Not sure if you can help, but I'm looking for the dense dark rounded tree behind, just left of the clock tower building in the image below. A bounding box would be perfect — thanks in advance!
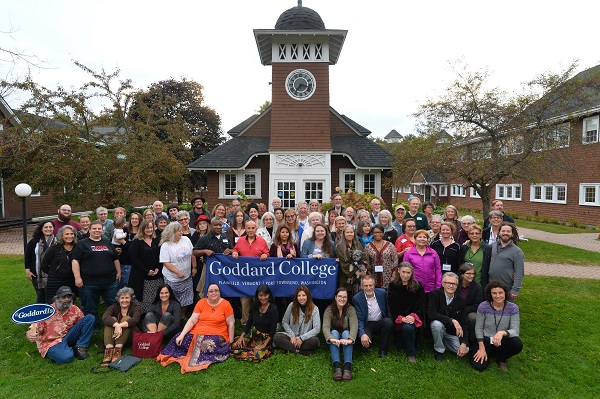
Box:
[131,78,224,202]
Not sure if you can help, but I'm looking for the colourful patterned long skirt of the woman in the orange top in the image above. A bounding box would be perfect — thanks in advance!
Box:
[156,333,230,374]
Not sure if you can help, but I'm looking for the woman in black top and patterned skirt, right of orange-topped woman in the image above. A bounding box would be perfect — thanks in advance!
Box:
[231,284,279,362]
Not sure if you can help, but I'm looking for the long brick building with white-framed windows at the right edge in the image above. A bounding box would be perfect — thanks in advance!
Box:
[403,65,600,225]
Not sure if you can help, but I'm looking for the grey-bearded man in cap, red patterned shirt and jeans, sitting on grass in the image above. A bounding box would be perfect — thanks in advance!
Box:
[26,286,95,364]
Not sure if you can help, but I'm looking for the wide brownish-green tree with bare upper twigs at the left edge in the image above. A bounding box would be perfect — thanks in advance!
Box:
[0,62,219,205]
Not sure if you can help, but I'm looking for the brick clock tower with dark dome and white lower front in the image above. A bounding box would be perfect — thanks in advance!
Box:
[254,6,347,205]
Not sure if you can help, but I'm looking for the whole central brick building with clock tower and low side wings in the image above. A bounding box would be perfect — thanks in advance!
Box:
[188,6,392,208]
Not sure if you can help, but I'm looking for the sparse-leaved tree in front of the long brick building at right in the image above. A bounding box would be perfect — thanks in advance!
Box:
[408,63,597,211]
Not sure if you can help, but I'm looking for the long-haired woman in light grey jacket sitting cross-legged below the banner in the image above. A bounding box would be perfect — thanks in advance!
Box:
[273,285,321,356]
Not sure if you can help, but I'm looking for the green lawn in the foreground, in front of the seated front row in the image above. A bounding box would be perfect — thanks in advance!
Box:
[0,256,600,399]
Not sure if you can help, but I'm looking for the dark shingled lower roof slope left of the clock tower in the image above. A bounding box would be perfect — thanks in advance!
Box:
[187,136,270,170]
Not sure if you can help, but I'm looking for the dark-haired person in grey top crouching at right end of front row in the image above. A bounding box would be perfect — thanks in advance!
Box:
[471,280,523,371]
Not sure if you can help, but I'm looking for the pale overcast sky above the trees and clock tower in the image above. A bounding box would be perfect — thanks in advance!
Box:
[0,0,600,138]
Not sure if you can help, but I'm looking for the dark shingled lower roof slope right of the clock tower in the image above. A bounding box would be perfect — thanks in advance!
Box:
[331,136,392,169]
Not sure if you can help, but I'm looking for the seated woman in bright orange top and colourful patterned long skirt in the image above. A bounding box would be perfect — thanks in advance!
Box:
[156,284,235,374]
